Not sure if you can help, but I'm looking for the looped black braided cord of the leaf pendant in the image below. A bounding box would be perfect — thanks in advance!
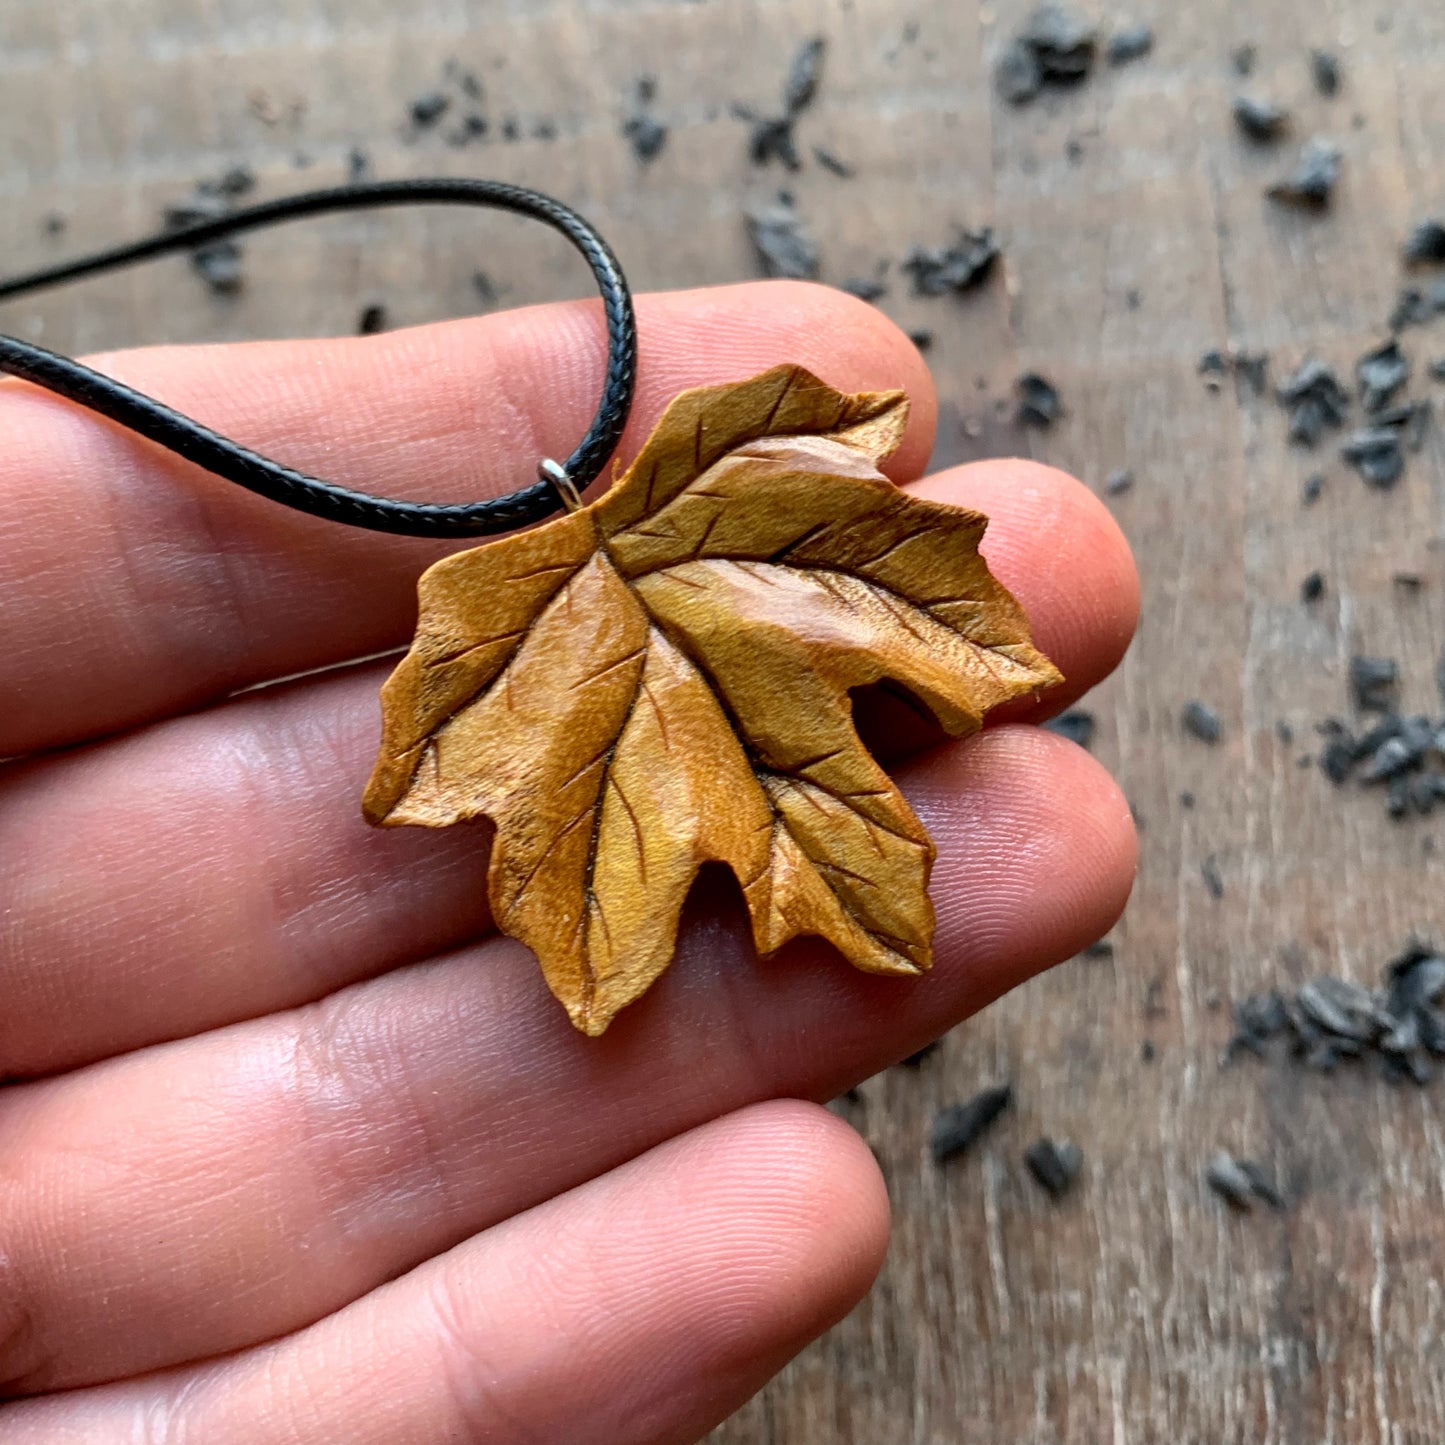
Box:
[0,181,637,538]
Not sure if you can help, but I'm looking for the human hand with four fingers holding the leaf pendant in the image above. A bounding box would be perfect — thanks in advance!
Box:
[0,283,1137,1445]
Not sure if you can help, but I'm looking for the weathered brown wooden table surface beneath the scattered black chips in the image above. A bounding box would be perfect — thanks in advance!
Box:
[0,0,1445,1445]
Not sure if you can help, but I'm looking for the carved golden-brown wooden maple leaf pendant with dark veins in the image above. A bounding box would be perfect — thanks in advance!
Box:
[364,367,1059,1035]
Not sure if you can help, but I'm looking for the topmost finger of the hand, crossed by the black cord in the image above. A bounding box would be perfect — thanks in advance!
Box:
[0,282,933,757]
